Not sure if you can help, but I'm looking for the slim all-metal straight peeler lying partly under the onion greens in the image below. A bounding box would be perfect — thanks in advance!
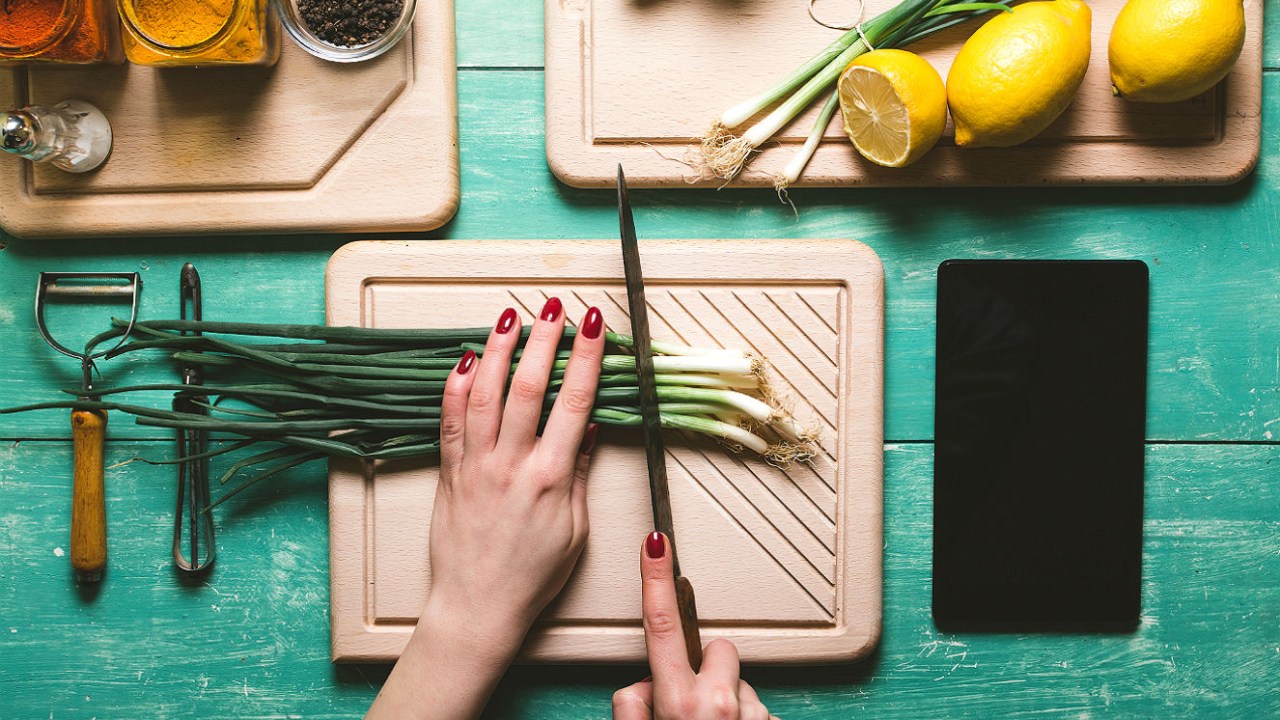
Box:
[173,263,218,574]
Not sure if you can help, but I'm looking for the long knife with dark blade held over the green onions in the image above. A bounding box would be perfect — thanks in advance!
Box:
[618,165,703,671]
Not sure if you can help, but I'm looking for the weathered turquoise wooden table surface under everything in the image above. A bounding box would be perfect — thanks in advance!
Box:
[0,0,1280,720]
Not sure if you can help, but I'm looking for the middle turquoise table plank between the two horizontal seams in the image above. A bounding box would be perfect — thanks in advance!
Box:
[0,72,1280,442]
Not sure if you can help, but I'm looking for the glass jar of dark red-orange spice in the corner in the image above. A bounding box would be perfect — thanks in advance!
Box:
[0,0,123,64]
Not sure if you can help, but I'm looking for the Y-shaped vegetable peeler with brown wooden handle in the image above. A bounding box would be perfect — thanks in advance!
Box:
[36,273,142,583]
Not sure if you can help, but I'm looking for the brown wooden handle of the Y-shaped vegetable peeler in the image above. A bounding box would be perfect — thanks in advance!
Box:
[72,410,106,582]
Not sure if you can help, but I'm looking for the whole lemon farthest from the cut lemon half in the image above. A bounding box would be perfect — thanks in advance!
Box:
[1107,0,1244,102]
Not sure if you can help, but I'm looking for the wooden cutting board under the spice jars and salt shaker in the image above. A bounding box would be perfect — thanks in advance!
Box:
[0,0,458,237]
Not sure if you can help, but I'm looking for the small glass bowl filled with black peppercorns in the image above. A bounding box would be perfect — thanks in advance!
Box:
[271,0,416,63]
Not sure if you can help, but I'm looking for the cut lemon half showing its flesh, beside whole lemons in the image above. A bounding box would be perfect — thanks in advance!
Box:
[837,50,947,168]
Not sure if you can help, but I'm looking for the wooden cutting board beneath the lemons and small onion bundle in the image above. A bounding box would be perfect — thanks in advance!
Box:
[545,0,1263,187]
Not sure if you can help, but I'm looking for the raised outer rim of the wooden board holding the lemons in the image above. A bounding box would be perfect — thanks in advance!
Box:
[544,0,1265,190]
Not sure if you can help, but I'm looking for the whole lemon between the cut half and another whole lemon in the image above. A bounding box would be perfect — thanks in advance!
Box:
[947,0,1092,147]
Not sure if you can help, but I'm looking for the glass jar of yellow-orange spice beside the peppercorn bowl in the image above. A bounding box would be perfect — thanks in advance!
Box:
[117,0,280,65]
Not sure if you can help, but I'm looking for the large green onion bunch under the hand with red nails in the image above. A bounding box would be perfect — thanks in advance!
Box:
[0,320,815,505]
